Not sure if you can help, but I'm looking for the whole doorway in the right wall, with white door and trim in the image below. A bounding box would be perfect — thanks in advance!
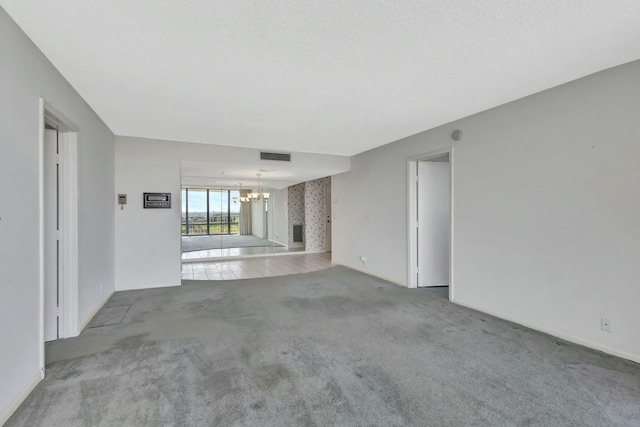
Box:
[408,148,453,299]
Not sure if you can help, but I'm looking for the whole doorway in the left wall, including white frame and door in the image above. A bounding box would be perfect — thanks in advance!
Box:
[39,99,79,369]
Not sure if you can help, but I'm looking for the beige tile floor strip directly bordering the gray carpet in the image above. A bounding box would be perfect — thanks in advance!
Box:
[182,253,331,280]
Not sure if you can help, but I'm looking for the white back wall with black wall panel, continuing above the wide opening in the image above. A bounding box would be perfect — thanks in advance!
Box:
[111,136,350,290]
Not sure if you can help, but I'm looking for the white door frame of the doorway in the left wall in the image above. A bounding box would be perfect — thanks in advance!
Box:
[38,98,80,375]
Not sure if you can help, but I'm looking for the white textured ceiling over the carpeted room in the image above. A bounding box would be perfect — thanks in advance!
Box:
[0,0,640,155]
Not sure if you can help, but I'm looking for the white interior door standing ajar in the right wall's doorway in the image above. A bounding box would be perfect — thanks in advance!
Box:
[418,161,450,287]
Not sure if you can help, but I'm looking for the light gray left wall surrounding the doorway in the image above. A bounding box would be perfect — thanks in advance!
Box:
[0,8,114,424]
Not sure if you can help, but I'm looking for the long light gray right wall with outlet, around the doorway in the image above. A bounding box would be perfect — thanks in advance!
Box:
[332,62,640,361]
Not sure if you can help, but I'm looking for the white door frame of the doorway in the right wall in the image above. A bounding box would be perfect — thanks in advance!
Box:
[407,147,455,301]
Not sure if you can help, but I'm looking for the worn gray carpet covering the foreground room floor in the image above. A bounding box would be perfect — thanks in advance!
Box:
[7,267,640,426]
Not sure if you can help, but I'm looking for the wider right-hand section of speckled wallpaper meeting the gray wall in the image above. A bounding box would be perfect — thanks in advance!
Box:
[304,176,331,251]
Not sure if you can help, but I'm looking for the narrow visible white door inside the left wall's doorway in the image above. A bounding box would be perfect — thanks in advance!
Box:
[43,129,59,341]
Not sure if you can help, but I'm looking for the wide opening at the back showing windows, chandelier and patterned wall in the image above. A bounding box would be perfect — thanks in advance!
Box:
[181,172,332,272]
